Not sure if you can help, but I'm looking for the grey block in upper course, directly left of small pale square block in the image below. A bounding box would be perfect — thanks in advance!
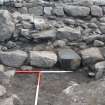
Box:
[29,6,43,16]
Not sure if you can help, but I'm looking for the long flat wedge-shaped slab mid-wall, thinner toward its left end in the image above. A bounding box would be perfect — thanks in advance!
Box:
[32,30,56,40]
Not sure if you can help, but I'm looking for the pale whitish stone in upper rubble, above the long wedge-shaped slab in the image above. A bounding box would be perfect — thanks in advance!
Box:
[34,17,49,30]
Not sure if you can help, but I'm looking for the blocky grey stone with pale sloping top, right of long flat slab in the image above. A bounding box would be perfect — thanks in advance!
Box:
[57,26,81,40]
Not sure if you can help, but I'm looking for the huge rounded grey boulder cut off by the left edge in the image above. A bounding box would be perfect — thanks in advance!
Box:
[0,10,15,41]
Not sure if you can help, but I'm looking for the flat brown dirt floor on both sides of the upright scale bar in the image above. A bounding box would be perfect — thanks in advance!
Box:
[11,69,92,105]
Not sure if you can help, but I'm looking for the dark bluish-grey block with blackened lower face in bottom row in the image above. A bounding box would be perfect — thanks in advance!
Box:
[58,49,81,70]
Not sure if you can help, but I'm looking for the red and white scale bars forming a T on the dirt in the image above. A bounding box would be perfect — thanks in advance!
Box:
[16,69,73,105]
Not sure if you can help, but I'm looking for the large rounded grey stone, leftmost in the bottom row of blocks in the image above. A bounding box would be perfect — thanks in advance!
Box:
[0,50,27,67]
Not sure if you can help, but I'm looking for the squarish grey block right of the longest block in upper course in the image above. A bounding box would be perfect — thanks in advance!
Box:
[91,6,103,17]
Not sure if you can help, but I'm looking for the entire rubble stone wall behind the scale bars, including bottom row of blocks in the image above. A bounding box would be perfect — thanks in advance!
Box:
[0,0,105,78]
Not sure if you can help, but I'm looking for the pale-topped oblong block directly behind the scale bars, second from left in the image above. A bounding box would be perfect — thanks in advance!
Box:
[30,51,57,68]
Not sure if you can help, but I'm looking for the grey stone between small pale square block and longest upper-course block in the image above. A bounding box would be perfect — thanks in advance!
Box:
[52,6,64,17]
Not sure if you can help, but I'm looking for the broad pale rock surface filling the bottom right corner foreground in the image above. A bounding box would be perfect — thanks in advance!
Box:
[53,80,105,105]
